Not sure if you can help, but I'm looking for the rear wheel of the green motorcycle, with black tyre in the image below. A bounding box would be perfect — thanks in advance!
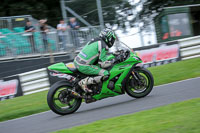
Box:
[47,83,82,115]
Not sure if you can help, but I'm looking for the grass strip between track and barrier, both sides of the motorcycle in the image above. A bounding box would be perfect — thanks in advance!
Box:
[0,58,200,121]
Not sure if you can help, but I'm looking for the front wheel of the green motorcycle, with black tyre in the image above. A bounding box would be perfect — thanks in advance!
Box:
[125,67,154,98]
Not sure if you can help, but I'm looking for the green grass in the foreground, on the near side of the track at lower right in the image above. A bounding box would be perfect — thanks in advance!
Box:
[55,98,200,133]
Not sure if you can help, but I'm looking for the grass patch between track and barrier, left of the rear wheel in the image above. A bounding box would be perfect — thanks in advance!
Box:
[0,91,49,121]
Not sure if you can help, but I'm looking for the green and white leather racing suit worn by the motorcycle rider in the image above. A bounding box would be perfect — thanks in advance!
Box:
[74,38,112,76]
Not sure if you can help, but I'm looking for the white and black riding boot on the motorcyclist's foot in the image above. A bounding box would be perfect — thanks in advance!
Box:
[78,76,102,93]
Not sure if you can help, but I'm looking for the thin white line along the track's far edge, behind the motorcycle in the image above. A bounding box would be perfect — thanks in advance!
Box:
[0,77,200,124]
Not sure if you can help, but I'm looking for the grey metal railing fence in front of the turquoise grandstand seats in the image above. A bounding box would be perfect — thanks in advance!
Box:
[0,26,100,57]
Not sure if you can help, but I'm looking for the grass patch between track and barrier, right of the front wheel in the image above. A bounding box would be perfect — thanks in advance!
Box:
[149,58,200,85]
